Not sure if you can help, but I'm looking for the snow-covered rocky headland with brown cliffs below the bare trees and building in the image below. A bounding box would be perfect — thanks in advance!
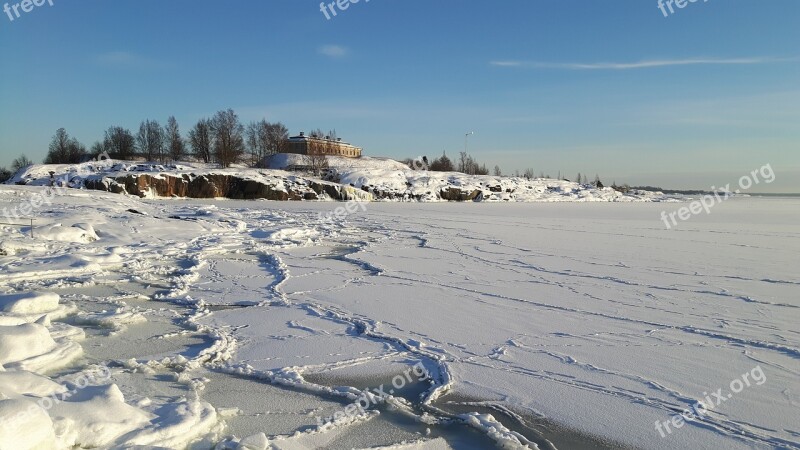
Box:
[17,160,665,202]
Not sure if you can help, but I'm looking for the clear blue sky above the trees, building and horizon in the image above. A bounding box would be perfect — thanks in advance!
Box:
[0,0,800,192]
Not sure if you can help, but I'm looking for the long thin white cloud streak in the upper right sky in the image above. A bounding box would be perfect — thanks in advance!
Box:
[489,57,798,70]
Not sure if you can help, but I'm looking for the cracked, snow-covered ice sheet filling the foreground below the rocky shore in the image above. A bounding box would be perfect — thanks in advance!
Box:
[0,186,800,449]
